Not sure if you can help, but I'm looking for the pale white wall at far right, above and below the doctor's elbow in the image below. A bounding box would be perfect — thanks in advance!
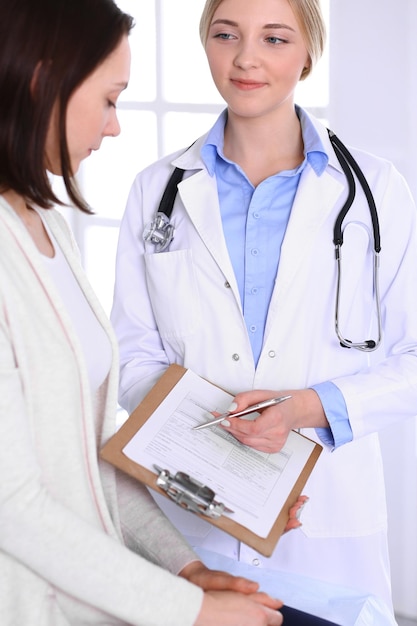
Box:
[329,0,417,618]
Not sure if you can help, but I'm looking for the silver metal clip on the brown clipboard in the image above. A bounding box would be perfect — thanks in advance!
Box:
[154,465,233,519]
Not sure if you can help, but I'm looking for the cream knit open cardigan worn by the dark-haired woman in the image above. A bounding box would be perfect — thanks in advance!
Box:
[0,196,202,626]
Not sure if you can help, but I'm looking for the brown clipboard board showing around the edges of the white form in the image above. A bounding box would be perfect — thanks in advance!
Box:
[100,364,323,557]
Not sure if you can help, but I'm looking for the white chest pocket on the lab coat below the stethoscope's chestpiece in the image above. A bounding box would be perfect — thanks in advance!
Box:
[145,250,201,338]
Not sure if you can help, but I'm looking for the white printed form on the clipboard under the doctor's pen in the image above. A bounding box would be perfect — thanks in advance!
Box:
[123,370,317,538]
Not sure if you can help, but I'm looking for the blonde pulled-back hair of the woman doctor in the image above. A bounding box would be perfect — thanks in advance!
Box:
[200,0,326,80]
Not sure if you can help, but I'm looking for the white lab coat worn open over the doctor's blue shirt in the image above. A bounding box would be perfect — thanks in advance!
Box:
[112,109,417,612]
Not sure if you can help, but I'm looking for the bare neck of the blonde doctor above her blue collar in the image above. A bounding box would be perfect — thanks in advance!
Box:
[224,109,304,186]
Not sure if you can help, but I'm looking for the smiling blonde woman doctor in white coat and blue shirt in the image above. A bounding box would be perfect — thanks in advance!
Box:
[112,0,417,624]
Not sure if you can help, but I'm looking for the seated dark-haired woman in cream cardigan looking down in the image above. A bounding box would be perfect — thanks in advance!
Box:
[0,0,282,626]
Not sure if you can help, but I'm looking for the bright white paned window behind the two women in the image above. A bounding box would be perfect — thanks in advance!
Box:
[70,0,329,312]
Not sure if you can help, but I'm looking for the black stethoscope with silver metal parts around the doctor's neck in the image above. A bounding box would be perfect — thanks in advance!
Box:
[143,130,382,352]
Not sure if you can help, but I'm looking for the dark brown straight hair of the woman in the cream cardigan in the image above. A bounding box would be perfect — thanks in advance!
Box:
[0,0,133,212]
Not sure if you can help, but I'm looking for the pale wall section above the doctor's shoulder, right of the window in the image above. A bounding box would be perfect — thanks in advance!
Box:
[330,0,417,195]
